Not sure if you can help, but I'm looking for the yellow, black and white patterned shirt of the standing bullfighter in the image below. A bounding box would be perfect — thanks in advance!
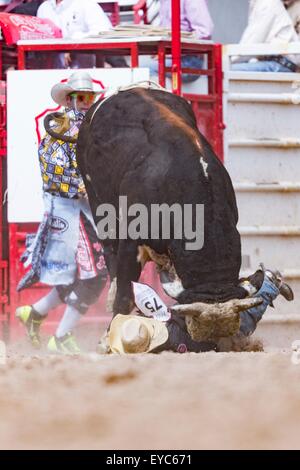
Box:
[38,110,86,199]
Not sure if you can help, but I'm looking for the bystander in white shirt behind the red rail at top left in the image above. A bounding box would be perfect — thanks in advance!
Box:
[37,0,112,69]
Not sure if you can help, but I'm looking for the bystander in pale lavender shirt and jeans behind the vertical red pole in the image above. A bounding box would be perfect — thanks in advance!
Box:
[139,0,213,83]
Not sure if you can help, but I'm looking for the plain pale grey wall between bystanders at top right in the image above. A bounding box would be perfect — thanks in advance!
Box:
[207,0,249,44]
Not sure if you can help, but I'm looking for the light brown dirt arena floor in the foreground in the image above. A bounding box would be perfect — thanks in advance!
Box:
[0,324,300,450]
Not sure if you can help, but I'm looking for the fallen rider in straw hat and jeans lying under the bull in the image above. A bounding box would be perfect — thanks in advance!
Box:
[107,265,294,354]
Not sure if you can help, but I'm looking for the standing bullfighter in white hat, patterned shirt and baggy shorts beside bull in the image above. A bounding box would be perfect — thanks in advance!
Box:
[16,71,107,354]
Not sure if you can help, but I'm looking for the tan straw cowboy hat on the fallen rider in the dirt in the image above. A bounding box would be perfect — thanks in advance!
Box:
[109,314,169,354]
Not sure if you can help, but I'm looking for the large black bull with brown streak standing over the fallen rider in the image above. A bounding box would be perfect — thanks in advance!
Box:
[77,87,246,313]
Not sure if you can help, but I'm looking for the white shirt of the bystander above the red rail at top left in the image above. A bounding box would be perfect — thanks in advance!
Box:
[37,0,112,39]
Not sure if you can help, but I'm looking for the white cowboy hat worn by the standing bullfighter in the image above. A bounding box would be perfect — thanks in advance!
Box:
[51,71,100,106]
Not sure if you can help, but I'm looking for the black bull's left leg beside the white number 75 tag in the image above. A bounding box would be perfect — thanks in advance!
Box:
[114,240,141,315]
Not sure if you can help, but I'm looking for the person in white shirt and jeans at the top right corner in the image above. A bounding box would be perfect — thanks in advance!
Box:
[231,0,300,72]
